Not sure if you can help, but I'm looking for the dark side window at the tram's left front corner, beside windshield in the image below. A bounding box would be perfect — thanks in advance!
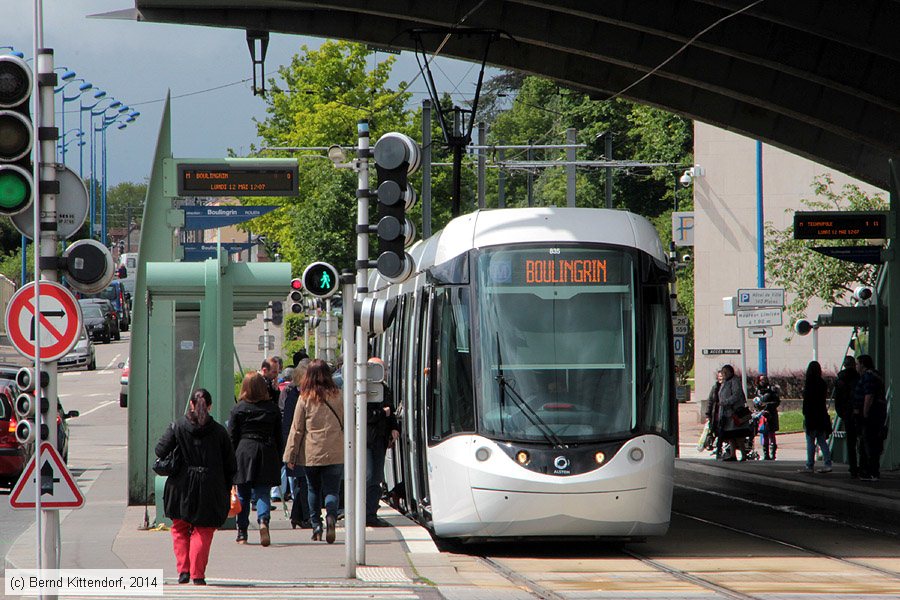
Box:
[428,287,475,440]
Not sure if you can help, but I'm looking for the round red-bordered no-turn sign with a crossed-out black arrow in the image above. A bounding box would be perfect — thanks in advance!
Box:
[6,281,81,362]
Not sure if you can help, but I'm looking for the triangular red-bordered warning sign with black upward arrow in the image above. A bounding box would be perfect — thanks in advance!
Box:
[9,442,84,510]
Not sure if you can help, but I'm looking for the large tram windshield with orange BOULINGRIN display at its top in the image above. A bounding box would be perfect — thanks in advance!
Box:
[476,247,636,444]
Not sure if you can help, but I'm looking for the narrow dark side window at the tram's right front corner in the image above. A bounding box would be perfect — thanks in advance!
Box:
[643,285,672,434]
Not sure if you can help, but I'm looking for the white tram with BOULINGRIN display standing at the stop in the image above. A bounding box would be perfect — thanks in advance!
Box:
[370,208,677,540]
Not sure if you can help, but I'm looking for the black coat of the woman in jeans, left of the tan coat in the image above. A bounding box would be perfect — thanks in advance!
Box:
[228,400,284,486]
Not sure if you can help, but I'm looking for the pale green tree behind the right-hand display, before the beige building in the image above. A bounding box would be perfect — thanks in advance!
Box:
[766,174,887,323]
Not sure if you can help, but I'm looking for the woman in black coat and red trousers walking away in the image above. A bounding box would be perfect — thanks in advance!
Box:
[156,388,237,585]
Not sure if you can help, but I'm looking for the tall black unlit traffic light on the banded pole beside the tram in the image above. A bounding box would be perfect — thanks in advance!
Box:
[374,132,421,282]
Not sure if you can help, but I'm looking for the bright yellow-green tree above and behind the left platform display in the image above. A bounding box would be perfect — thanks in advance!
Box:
[244,41,419,274]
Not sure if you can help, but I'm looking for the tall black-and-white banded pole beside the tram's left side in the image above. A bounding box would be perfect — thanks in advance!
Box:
[345,119,371,565]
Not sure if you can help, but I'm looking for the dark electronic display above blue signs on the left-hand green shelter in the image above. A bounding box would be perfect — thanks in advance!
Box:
[177,161,299,196]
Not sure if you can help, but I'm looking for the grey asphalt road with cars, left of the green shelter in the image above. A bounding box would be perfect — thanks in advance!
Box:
[0,333,129,568]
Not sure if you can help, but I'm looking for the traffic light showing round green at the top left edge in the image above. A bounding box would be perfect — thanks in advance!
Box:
[0,55,35,216]
